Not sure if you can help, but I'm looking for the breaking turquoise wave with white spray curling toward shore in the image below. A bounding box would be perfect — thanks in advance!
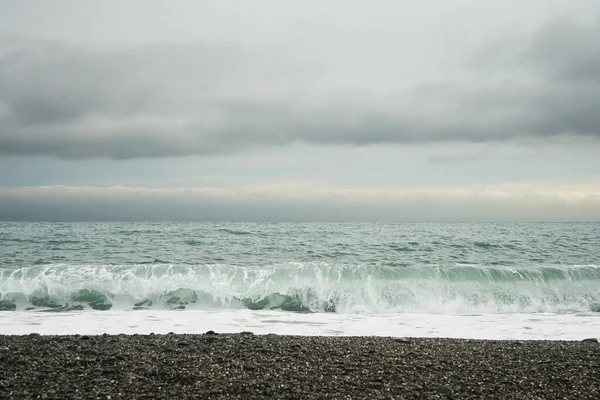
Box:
[0,260,600,314]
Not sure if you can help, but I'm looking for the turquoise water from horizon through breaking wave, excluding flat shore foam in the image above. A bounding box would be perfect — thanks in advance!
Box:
[0,222,600,314]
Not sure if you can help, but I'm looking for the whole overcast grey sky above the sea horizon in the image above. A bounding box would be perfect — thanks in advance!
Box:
[0,0,600,222]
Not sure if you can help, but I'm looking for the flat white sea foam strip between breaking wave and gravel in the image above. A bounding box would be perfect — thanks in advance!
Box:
[0,310,600,340]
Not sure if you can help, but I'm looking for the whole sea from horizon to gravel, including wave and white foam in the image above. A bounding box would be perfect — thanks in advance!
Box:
[0,222,600,340]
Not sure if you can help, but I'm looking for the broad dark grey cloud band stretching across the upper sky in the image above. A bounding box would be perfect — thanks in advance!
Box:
[0,17,600,159]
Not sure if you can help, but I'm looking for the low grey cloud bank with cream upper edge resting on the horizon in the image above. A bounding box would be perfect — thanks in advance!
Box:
[0,182,600,222]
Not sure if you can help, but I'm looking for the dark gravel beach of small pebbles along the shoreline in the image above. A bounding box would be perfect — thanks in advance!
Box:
[0,332,600,400]
